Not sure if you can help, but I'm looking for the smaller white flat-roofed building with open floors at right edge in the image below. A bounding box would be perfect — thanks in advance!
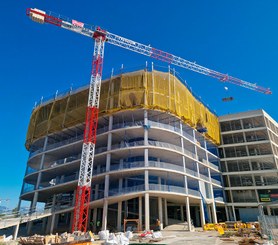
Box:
[219,110,278,221]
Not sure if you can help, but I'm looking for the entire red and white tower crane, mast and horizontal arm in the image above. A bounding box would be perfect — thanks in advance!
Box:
[26,8,271,231]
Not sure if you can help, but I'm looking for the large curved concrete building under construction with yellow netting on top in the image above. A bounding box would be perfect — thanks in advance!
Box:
[19,69,226,233]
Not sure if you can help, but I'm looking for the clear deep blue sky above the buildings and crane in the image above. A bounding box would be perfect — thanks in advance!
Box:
[0,0,278,208]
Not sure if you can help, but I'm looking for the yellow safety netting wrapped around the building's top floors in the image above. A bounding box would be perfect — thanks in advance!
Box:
[26,70,220,149]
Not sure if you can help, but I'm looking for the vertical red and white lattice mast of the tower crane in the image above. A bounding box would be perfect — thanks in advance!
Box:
[72,32,105,231]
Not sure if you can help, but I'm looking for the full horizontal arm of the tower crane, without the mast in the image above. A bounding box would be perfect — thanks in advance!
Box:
[27,8,272,94]
